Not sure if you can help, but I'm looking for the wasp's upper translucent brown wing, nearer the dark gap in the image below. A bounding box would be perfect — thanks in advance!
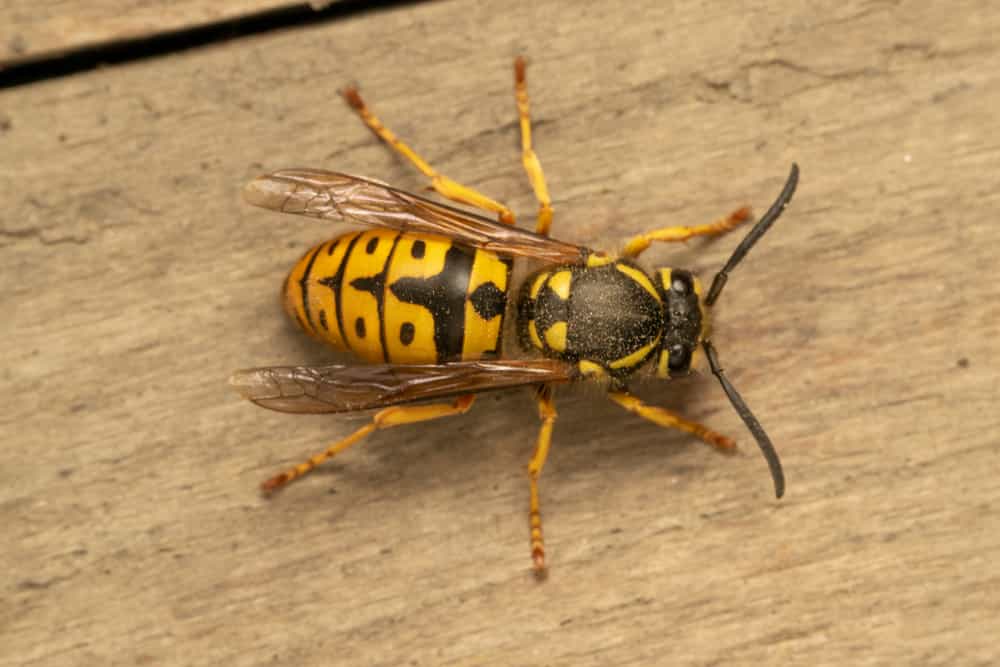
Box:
[243,169,593,264]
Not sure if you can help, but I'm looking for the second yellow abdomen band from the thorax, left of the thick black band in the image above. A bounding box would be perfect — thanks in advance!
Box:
[384,234,451,364]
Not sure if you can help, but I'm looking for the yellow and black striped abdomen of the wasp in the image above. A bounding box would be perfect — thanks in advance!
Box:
[284,229,511,364]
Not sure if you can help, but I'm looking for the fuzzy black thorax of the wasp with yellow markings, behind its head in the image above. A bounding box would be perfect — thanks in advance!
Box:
[518,260,666,377]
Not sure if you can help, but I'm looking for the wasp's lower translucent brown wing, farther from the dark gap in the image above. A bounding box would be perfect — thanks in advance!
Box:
[229,359,576,413]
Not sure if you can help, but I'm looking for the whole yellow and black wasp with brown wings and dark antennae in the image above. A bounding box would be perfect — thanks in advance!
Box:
[231,58,799,575]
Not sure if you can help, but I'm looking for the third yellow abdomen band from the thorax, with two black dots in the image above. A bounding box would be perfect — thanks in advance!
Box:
[340,229,399,362]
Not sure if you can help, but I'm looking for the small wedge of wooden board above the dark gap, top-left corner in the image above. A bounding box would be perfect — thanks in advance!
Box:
[0,0,322,70]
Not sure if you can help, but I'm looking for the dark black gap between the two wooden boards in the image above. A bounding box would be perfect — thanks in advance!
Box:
[0,0,426,89]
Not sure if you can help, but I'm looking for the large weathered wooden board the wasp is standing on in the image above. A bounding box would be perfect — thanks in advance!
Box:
[0,0,1000,666]
